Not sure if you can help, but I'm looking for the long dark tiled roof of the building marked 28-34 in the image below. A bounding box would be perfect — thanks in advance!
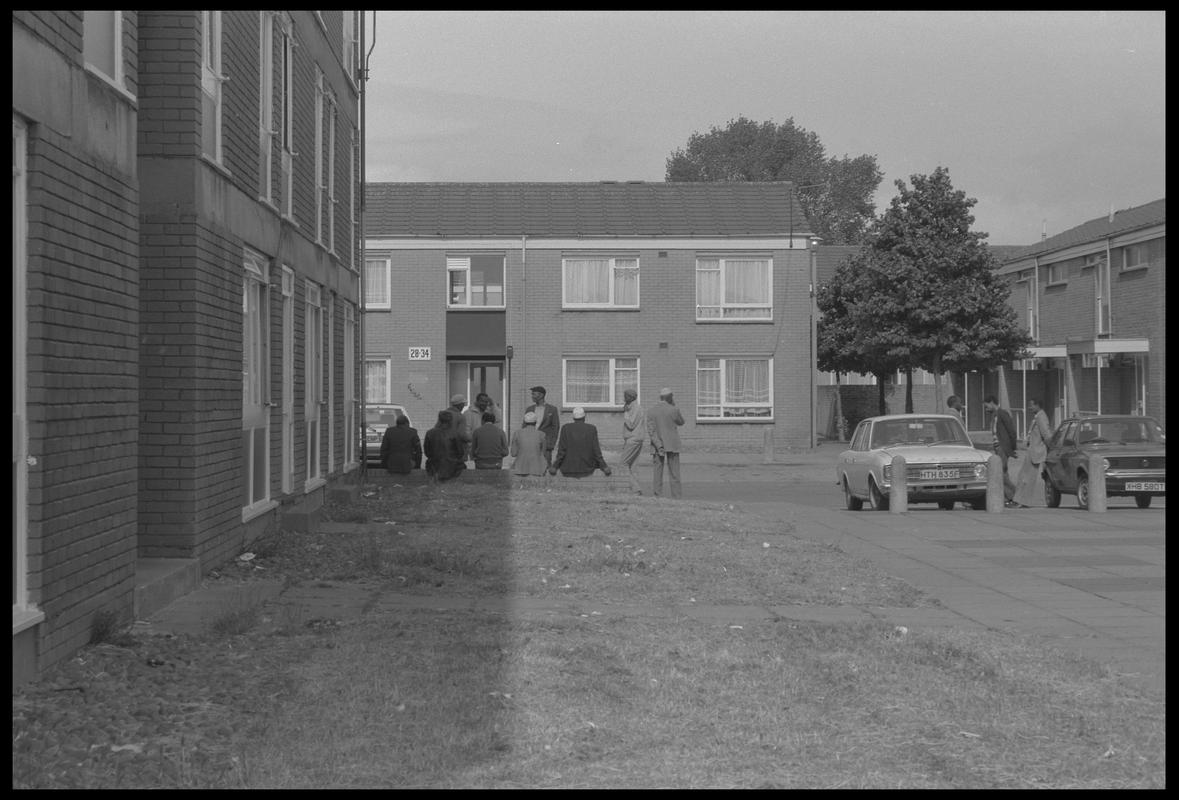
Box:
[364,181,810,238]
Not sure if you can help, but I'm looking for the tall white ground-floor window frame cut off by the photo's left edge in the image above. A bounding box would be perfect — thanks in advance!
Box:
[12,114,45,636]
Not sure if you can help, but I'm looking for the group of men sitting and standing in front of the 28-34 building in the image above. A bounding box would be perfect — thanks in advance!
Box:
[381,385,684,497]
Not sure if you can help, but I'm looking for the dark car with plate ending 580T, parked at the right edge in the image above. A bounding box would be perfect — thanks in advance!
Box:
[1043,415,1167,508]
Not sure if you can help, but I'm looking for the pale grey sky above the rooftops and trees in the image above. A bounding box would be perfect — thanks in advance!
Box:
[364,11,1166,245]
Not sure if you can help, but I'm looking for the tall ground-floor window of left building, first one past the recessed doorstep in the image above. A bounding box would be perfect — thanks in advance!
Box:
[242,250,270,511]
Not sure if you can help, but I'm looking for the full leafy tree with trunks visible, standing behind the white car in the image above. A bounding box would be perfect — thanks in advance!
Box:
[818,162,1030,414]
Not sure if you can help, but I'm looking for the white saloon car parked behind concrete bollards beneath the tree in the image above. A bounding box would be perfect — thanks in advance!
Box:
[836,414,990,511]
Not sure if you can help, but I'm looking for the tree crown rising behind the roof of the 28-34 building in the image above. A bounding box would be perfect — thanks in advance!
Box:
[666,117,883,244]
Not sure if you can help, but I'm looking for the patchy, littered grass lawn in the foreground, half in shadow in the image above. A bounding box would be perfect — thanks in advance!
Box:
[13,475,1166,788]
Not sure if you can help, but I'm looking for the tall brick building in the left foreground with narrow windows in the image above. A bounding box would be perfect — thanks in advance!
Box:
[13,11,362,682]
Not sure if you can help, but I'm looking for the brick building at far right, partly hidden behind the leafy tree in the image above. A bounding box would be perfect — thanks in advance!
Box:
[959,199,1167,438]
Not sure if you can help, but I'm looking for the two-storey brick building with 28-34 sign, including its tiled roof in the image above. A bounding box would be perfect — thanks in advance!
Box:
[364,181,815,452]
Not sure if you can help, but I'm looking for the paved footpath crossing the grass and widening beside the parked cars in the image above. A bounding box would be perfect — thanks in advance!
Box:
[141,445,1166,694]
